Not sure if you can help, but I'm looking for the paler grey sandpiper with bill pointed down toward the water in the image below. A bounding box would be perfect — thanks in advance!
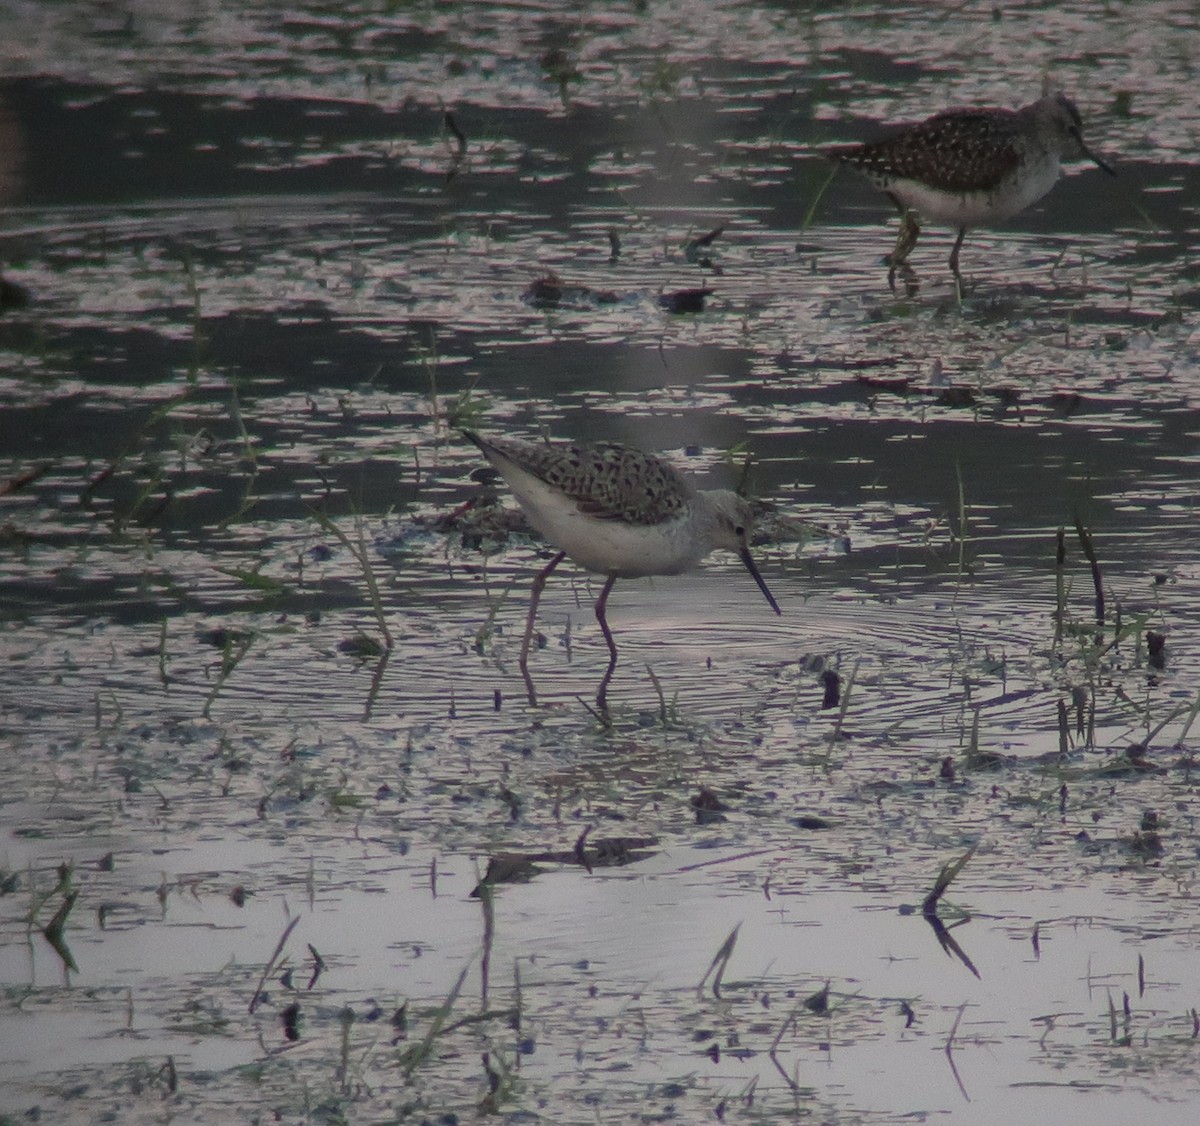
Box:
[463,430,780,714]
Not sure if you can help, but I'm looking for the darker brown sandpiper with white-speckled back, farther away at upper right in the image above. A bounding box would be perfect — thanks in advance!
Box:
[829,92,1116,283]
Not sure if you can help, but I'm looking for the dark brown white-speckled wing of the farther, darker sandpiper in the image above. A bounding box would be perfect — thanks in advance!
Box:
[834,109,1022,192]
